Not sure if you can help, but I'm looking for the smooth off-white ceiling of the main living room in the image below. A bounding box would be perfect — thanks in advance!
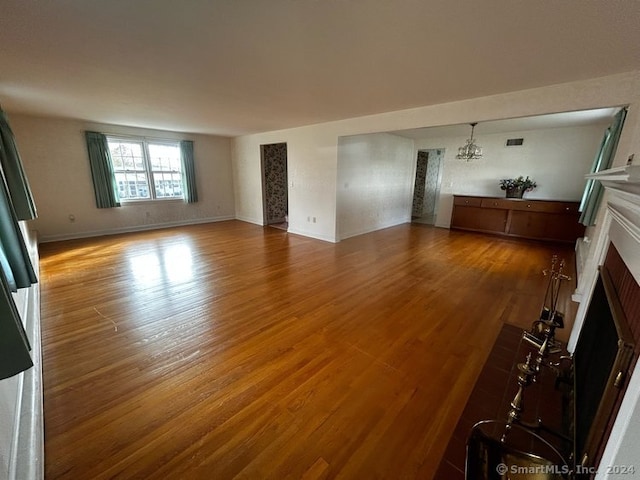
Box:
[0,0,640,135]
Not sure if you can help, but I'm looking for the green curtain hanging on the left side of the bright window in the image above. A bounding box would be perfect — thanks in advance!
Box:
[85,132,120,208]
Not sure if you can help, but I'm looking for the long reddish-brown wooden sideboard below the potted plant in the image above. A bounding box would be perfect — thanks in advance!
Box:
[451,195,584,243]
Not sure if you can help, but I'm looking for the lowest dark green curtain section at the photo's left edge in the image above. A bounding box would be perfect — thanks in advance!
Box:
[0,264,33,380]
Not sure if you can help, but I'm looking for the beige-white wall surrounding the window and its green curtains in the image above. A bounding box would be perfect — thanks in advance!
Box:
[9,114,234,241]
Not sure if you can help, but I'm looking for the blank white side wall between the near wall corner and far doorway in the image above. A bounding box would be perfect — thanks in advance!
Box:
[337,133,416,239]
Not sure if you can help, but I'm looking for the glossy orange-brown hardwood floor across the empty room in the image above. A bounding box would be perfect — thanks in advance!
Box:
[40,221,573,480]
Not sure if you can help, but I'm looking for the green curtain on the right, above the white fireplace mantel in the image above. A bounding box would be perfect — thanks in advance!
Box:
[578,108,627,227]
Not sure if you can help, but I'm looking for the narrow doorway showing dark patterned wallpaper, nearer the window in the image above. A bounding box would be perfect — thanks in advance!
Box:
[260,143,289,230]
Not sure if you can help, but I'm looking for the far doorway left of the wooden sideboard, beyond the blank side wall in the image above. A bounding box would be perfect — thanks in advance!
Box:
[411,148,444,225]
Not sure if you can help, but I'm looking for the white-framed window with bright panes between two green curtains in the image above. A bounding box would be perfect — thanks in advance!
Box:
[107,137,183,202]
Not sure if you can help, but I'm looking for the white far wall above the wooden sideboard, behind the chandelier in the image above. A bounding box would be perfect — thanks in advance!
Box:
[416,125,608,228]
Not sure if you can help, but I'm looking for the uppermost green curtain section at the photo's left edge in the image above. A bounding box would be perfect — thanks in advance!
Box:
[0,109,37,220]
